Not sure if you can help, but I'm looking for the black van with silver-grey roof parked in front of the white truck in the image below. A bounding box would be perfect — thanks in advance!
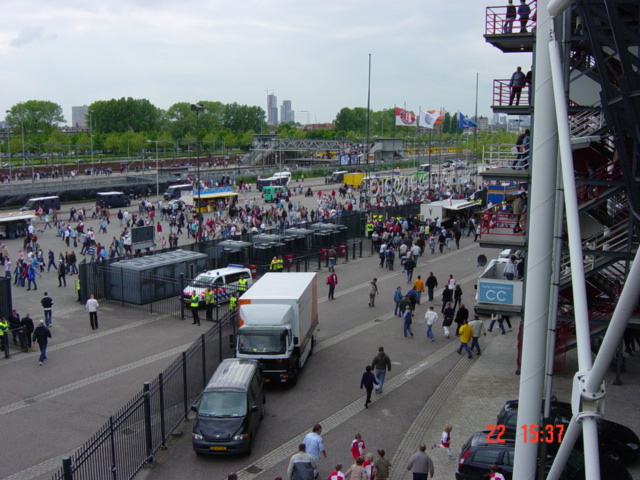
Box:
[191,358,266,454]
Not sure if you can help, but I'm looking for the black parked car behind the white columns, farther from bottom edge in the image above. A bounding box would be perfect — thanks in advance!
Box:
[496,399,640,464]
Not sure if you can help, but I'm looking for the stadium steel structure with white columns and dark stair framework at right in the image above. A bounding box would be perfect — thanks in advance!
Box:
[485,0,640,480]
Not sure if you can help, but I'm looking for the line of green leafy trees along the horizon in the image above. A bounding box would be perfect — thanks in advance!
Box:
[0,97,510,155]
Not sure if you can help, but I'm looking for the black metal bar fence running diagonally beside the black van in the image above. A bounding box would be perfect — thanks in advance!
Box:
[51,306,236,480]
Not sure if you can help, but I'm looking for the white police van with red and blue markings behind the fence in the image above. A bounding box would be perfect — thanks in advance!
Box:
[182,265,253,308]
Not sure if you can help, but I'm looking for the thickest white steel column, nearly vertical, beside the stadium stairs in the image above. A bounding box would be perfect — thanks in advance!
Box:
[513,0,562,480]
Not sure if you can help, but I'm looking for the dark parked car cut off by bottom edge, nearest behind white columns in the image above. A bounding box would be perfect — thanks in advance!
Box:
[456,430,633,480]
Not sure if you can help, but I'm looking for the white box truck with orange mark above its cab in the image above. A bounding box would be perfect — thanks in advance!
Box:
[236,273,318,385]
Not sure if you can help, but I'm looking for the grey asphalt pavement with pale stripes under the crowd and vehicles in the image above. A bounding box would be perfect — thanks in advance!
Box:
[0,182,640,480]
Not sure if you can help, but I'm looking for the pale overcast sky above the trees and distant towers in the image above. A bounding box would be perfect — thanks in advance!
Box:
[0,0,531,123]
